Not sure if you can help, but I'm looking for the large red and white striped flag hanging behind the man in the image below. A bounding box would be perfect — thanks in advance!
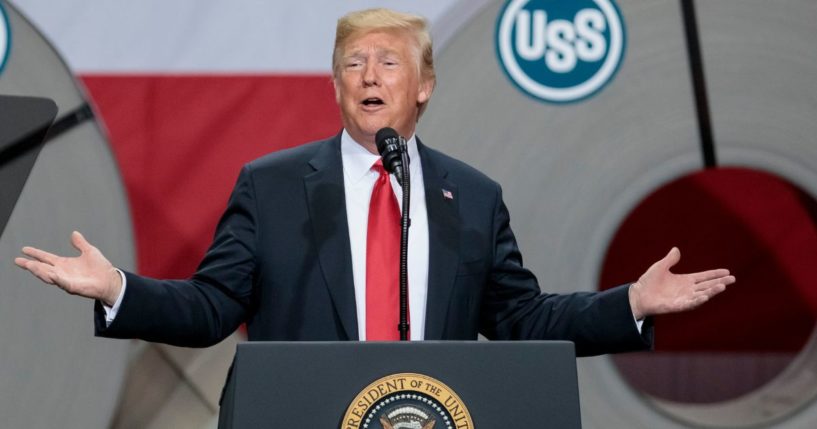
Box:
[15,0,454,278]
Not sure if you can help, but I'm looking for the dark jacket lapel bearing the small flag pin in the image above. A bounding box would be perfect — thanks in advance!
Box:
[417,139,459,340]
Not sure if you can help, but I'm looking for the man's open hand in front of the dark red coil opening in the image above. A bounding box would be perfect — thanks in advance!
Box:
[630,247,735,320]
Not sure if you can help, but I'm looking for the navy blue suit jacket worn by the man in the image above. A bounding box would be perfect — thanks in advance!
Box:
[96,135,652,355]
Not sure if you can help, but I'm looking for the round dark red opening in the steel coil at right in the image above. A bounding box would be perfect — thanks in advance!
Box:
[600,168,817,427]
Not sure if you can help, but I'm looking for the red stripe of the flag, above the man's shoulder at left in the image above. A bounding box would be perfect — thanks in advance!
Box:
[82,75,341,278]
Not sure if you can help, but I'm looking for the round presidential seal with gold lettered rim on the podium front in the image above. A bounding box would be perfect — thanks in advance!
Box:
[340,373,474,429]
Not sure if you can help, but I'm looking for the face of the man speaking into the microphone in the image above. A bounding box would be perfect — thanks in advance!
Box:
[334,30,432,152]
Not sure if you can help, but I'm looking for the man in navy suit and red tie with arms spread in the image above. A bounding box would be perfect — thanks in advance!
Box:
[15,9,735,355]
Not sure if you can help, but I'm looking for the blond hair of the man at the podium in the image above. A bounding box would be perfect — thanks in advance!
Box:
[332,8,436,114]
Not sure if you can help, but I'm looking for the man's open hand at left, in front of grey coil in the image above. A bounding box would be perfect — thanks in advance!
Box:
[14,231,122,307]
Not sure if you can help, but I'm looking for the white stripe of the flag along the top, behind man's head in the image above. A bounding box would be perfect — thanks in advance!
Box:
[14,0,456,74]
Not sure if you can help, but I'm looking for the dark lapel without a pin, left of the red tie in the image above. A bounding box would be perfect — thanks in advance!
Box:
[304,135,358,340]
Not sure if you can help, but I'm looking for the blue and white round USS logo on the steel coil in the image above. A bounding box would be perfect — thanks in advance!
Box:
[496,0,625,103]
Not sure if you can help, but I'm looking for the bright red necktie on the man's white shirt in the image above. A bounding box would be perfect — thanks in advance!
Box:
[366,160,400,341]
